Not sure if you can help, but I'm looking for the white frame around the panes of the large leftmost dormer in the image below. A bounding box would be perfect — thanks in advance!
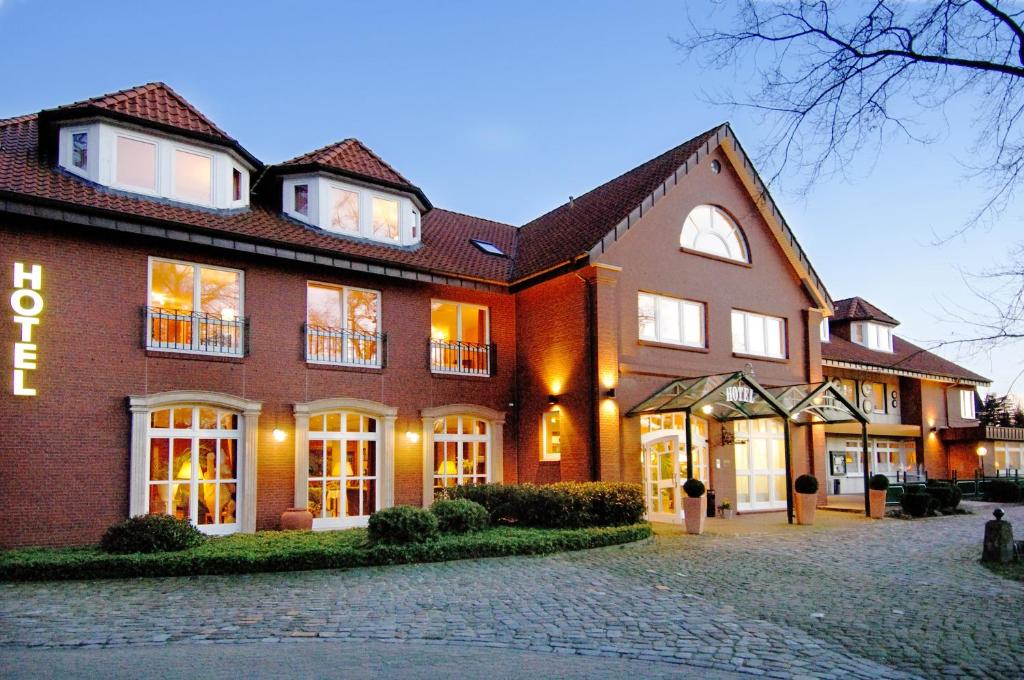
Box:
[57,121,254,209]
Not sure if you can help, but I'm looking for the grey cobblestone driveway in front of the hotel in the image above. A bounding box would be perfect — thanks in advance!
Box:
[0,504,1024,678]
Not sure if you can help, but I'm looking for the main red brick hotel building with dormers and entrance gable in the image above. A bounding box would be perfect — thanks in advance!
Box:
[0,83,987,546]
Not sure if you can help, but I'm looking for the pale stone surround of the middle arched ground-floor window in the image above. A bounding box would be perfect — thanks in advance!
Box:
[293,397,398,522]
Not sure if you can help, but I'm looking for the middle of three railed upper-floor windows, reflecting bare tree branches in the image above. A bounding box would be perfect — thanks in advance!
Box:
[306,284,381,367]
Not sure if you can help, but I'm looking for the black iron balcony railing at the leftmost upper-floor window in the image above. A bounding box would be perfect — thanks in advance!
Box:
[142,307,249,356]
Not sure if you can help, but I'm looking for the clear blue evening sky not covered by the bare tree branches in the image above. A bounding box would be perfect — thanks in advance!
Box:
[0,0,1024,393]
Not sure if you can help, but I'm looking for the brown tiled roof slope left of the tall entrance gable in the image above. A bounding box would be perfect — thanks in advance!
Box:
[512,126,720,279]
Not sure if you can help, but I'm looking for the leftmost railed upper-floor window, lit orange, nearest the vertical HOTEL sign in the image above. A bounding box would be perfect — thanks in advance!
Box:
[146,258,245,355]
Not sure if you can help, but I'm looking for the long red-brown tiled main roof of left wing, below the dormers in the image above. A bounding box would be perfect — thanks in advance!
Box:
[0,115,516,283]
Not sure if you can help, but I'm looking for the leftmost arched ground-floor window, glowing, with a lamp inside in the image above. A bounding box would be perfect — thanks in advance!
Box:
[146,405,240,534]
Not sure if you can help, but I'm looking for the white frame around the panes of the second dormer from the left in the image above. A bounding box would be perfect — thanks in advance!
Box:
[282,173,421,246]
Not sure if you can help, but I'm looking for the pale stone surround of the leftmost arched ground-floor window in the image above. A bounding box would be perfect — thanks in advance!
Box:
[128,390,263,534]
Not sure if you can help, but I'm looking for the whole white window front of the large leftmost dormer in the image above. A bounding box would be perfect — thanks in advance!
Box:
[57,120,252,209]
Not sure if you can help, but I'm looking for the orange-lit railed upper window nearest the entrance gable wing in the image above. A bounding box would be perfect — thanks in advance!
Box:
[430,300,490,375]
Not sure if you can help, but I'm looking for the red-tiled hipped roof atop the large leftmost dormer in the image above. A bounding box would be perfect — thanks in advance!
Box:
[39,82,262,167]
